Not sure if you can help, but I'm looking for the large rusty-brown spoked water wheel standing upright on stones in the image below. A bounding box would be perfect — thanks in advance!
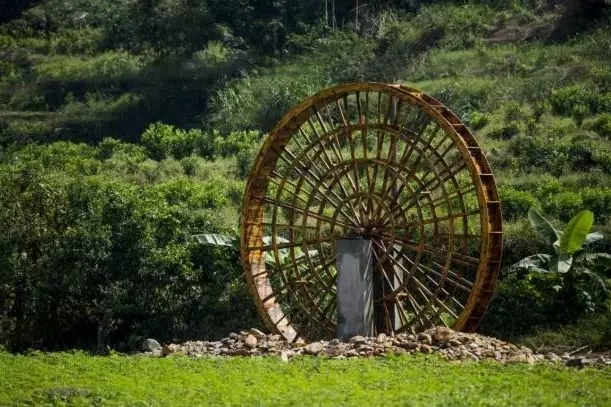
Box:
[241,83,502,341]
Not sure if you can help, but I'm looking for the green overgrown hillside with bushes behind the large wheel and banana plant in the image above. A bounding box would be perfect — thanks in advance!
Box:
[0,0,611,350]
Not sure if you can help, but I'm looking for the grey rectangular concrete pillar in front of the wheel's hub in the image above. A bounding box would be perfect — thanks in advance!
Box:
[337,238,375,340]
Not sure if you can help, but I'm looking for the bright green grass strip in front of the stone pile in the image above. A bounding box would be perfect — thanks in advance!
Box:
[0,353,611,406]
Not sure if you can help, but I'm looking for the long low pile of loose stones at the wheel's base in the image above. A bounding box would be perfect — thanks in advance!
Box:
[142,327,611,367]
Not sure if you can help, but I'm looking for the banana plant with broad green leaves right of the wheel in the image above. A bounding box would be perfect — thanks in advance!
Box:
[503,208,611,308]
